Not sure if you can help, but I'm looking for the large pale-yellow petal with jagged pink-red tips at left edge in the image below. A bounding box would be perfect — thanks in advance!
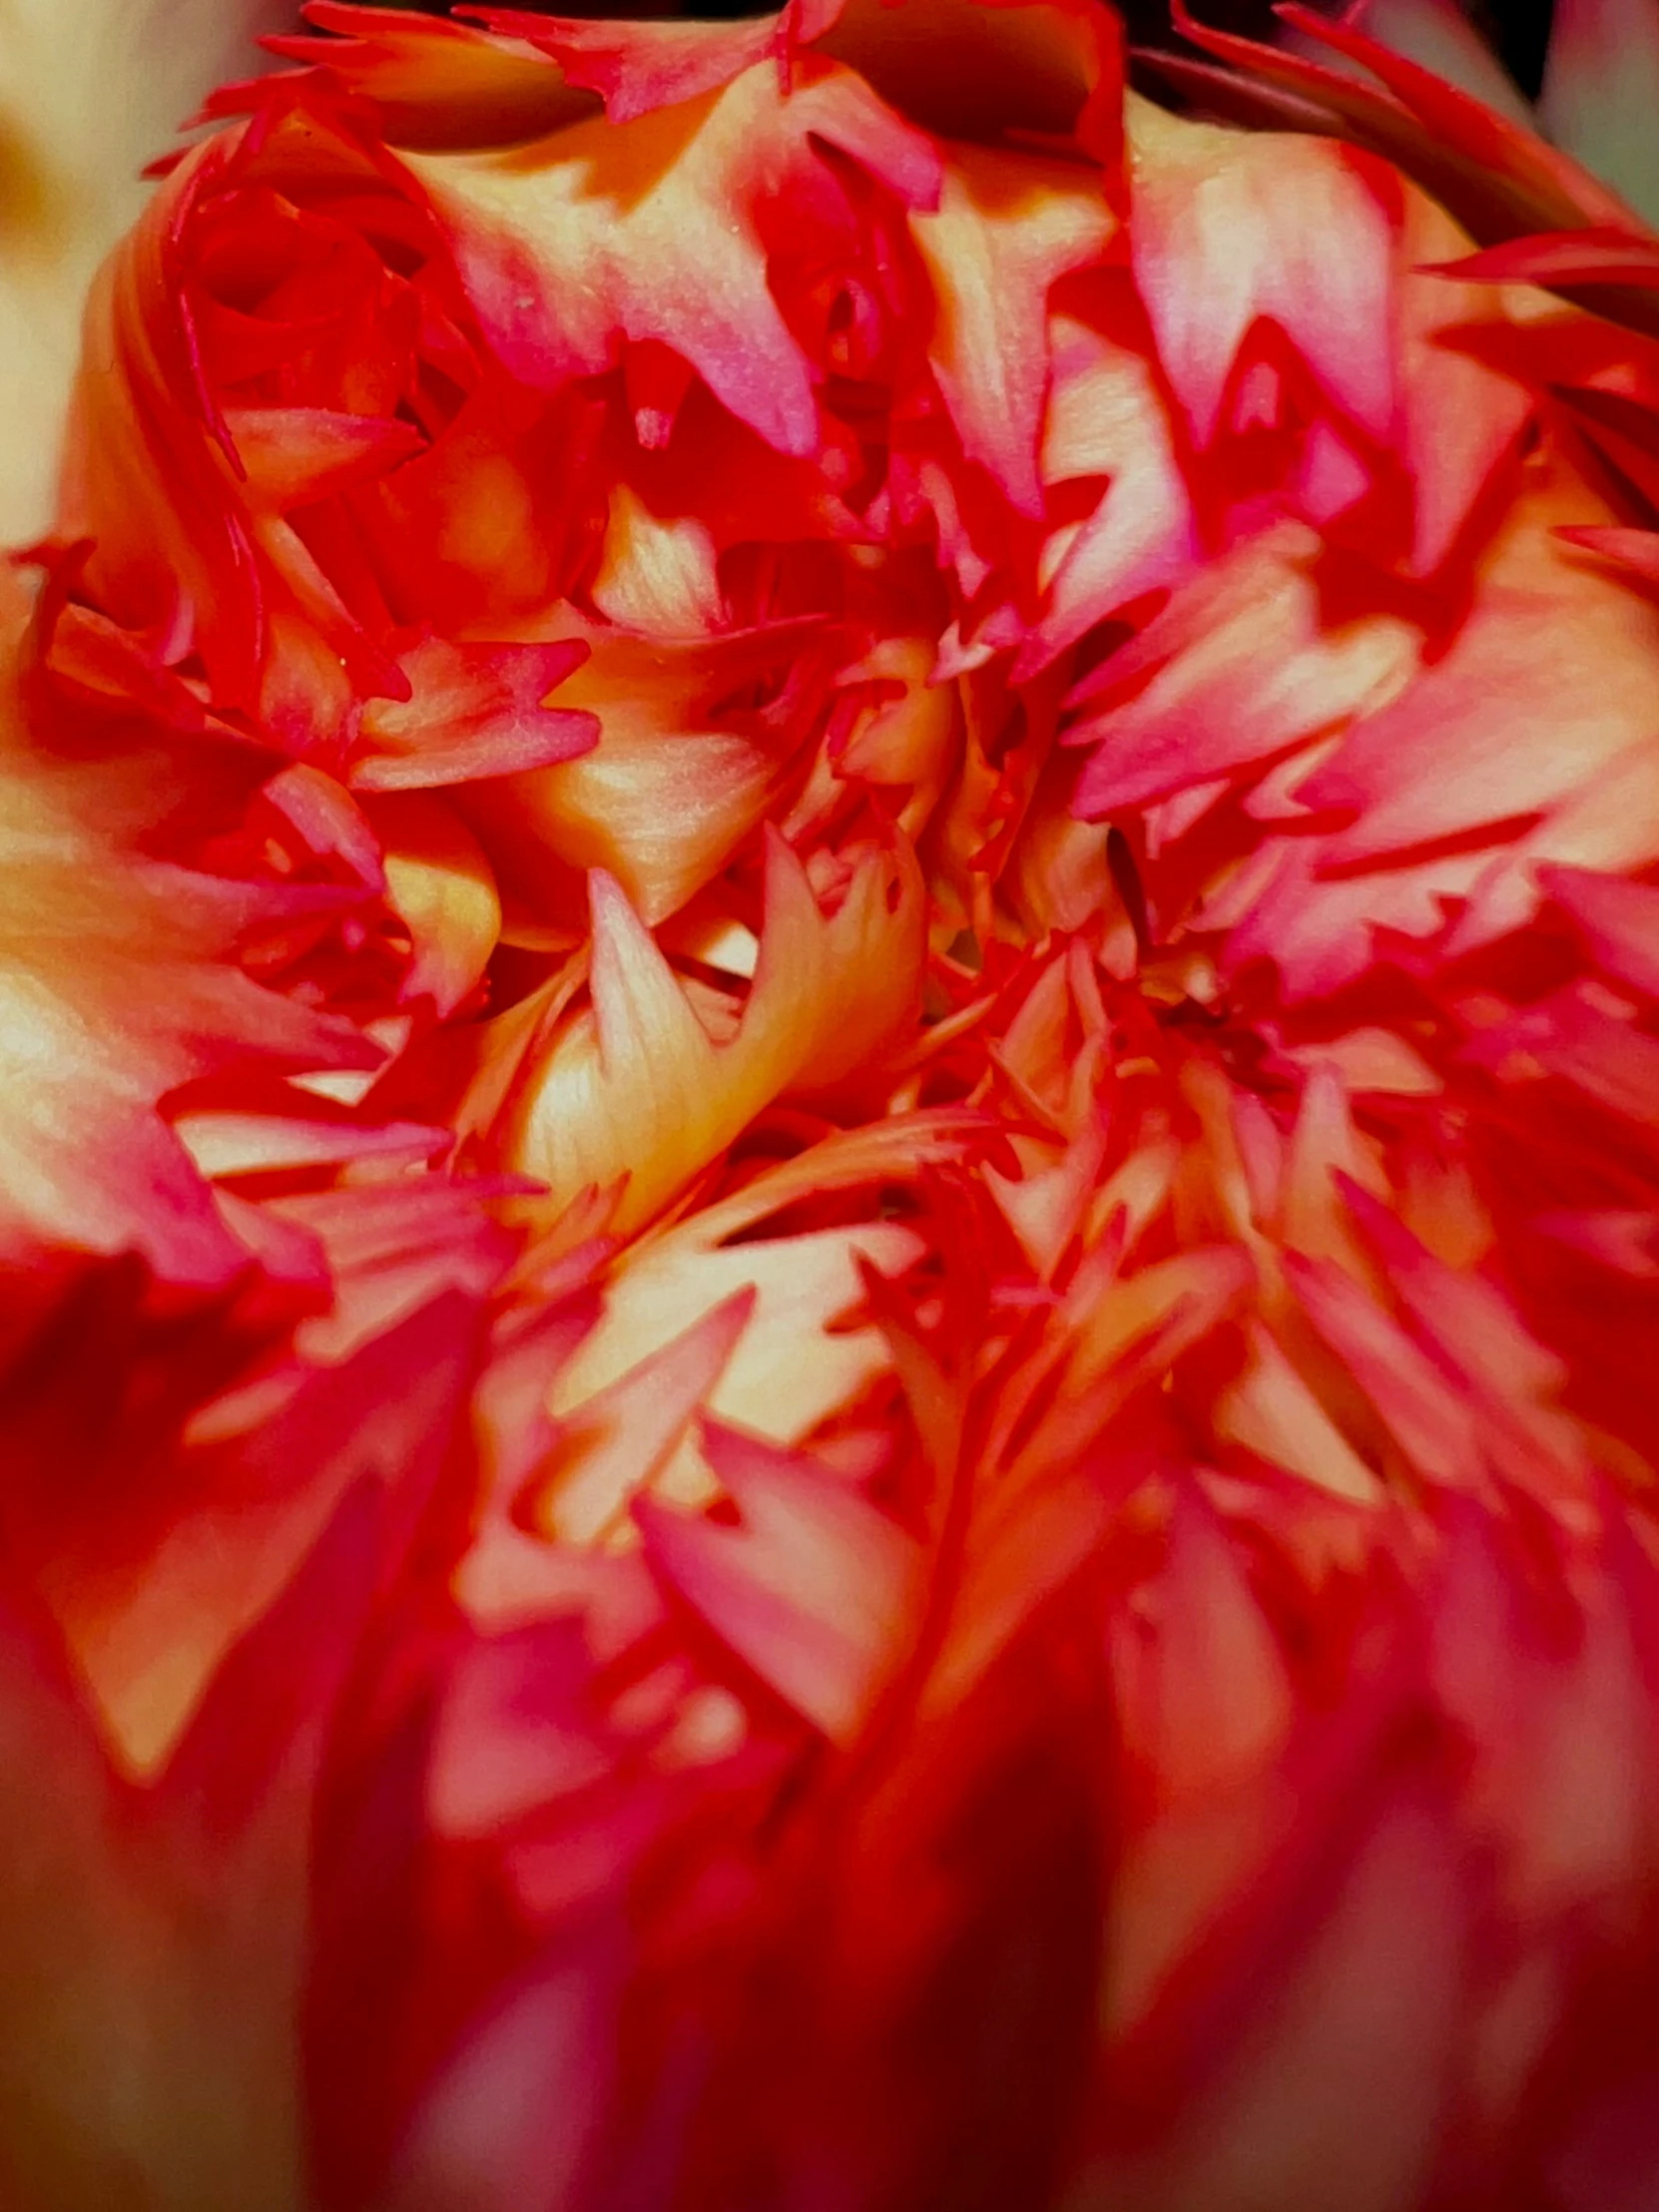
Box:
[0,571,380,1283]
